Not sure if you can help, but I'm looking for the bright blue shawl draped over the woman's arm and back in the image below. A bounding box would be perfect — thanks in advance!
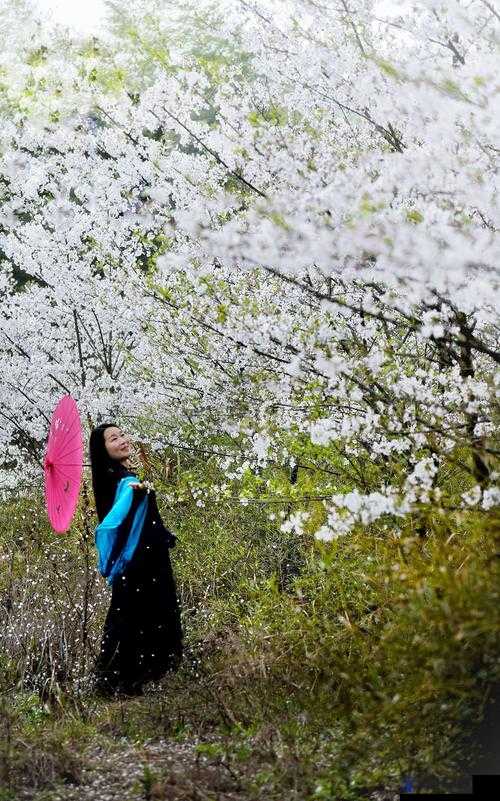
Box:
[95,476,148,584]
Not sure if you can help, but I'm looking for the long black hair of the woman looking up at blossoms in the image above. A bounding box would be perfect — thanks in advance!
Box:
[89,423,133,522]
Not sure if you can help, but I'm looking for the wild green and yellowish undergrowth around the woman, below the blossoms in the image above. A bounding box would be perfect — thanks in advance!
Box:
[0,446,500,801]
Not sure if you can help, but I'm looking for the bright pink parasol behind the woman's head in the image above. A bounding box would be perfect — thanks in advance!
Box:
[44,395,83,534]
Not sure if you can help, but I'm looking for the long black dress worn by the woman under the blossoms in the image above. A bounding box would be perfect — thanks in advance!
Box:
[95,473,183,693]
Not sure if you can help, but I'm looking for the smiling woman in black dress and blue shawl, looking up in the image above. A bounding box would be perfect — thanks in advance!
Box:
[89,423,182,695]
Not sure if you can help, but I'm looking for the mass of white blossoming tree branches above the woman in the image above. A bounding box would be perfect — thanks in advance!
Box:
[0,0,500,540]
